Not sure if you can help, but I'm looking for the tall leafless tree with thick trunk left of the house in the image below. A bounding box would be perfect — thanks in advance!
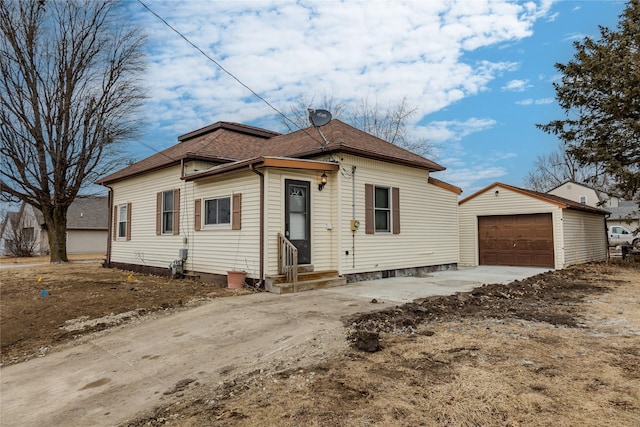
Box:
[0,0,145,262]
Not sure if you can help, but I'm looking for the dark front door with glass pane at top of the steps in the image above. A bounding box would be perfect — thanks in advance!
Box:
[284,179,311,264]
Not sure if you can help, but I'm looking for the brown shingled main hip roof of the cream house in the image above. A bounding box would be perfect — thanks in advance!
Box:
[97,119,445,184]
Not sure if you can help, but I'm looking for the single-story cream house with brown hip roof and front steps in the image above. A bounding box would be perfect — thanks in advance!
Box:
[98,119,461,292]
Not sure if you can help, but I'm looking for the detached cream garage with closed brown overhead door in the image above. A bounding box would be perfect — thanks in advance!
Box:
[459,183,608,269]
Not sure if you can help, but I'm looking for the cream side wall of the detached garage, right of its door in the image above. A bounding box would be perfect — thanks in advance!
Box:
[562,209,608,267]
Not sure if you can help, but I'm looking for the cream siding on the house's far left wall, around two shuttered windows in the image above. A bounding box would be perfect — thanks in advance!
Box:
[111,166,193,268]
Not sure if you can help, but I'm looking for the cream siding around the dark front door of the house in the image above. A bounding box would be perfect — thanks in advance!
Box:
[265,169,338,274]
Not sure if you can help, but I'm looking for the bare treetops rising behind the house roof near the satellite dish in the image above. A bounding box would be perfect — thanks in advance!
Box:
[282,94,433,156]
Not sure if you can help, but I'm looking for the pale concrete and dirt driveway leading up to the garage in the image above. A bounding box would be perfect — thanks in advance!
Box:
[0,267,548,427]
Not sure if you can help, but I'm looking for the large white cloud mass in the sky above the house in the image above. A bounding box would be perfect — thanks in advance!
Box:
[134,0,550,135]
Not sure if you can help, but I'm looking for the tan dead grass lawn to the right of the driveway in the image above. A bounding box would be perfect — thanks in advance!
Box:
[130,265,640,427]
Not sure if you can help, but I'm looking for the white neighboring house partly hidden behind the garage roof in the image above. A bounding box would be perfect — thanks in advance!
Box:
[548,181,640,234]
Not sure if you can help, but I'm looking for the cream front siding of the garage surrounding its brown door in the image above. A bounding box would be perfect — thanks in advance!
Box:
[458,187,563,268]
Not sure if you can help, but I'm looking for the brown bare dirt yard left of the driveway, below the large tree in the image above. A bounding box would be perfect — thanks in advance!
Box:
[0,256,250,366]
